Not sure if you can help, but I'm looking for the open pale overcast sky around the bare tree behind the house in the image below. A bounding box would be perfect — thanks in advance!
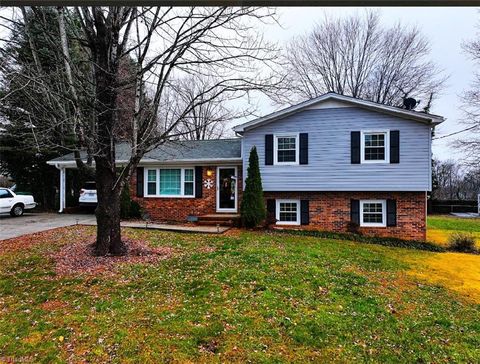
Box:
[253,7,480,159]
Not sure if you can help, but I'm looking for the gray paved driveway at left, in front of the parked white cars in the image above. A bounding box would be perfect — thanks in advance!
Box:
[0,213,95,240]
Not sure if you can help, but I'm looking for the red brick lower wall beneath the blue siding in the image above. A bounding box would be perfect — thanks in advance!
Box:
[265,192,426,240]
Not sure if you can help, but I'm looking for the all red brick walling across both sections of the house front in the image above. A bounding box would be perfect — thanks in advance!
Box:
[130,166,426,240]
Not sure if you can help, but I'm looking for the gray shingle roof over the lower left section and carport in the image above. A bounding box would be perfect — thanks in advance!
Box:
[49,138,242,162]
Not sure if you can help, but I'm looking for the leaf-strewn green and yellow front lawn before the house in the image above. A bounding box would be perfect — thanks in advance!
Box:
[0,227,480,363]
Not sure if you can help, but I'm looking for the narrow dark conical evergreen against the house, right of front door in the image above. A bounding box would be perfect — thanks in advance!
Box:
[240,147,266,228]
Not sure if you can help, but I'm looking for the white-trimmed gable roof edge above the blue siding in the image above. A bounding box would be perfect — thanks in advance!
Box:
[233,92,445,133]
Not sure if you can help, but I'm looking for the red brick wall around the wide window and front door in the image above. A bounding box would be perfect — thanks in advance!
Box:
[130,166,243,222]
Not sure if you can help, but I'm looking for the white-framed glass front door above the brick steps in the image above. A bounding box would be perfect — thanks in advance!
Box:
[217,167,237,212]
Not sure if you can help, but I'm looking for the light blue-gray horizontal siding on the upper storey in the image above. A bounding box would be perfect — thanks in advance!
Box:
[242,107,431,191]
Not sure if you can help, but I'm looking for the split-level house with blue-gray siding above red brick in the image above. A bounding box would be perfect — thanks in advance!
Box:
[49,93,444,240]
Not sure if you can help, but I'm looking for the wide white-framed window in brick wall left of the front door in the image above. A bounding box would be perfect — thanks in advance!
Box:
[146,168,195,197]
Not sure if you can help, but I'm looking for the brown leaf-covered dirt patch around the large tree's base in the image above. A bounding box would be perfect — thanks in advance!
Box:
[51,239,175,275]
